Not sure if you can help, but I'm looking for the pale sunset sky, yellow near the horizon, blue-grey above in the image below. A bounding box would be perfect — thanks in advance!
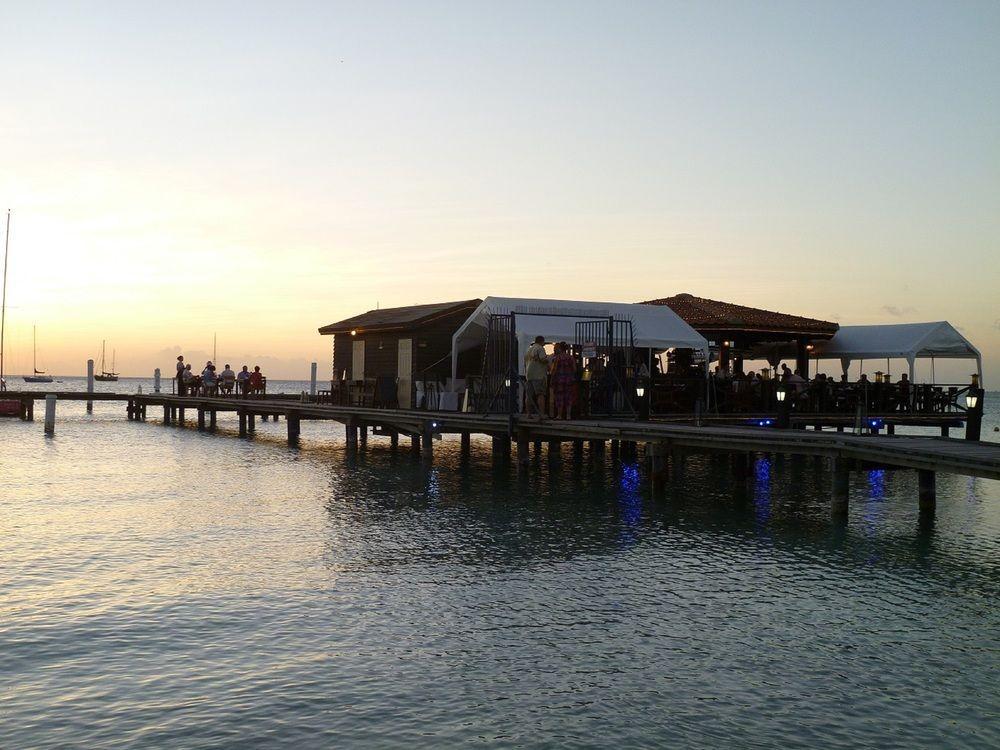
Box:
[0,2,1000,386]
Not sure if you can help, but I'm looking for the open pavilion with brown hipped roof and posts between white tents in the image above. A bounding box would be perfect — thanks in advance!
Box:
[643,294,840,376]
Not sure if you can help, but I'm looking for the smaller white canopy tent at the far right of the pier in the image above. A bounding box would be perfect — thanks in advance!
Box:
[812,320,983,383]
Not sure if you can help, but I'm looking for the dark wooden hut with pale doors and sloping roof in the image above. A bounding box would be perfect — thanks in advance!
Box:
[319,299,482,408]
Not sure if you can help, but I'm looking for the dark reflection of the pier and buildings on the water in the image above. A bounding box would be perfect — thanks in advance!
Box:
[310,444,1000,596]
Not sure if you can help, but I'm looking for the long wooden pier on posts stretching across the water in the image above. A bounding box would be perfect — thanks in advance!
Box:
[4,391,1000,515]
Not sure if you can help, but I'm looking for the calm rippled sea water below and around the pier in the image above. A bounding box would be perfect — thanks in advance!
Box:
[0,381,1000,748]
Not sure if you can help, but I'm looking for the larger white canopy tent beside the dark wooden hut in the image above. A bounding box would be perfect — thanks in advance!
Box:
[451,297,708,377]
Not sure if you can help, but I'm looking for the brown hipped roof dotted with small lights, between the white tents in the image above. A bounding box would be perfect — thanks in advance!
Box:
[642,293,838,339]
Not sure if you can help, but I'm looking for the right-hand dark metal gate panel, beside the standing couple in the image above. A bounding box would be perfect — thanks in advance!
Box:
[575,317,636,416]
